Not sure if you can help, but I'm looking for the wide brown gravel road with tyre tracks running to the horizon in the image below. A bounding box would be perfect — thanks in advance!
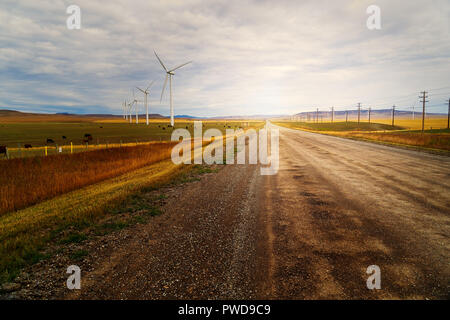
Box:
[8,124,450,299]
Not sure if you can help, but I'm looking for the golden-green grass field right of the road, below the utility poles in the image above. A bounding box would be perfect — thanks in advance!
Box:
[274,119,450,151]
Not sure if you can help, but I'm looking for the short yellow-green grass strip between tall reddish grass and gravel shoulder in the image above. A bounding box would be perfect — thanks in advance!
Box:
[0,160,197,283]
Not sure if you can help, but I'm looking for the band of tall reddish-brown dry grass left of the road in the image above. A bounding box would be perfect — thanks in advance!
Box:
[0,142,176,215]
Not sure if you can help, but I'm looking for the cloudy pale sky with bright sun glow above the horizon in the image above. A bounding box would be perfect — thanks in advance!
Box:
[0,0,450,117]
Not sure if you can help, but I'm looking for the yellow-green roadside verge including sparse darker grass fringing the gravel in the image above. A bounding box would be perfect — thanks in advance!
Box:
[0,160,219,283]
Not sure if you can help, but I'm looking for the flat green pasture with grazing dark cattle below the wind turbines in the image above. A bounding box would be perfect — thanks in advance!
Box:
[0,120,264,158]
